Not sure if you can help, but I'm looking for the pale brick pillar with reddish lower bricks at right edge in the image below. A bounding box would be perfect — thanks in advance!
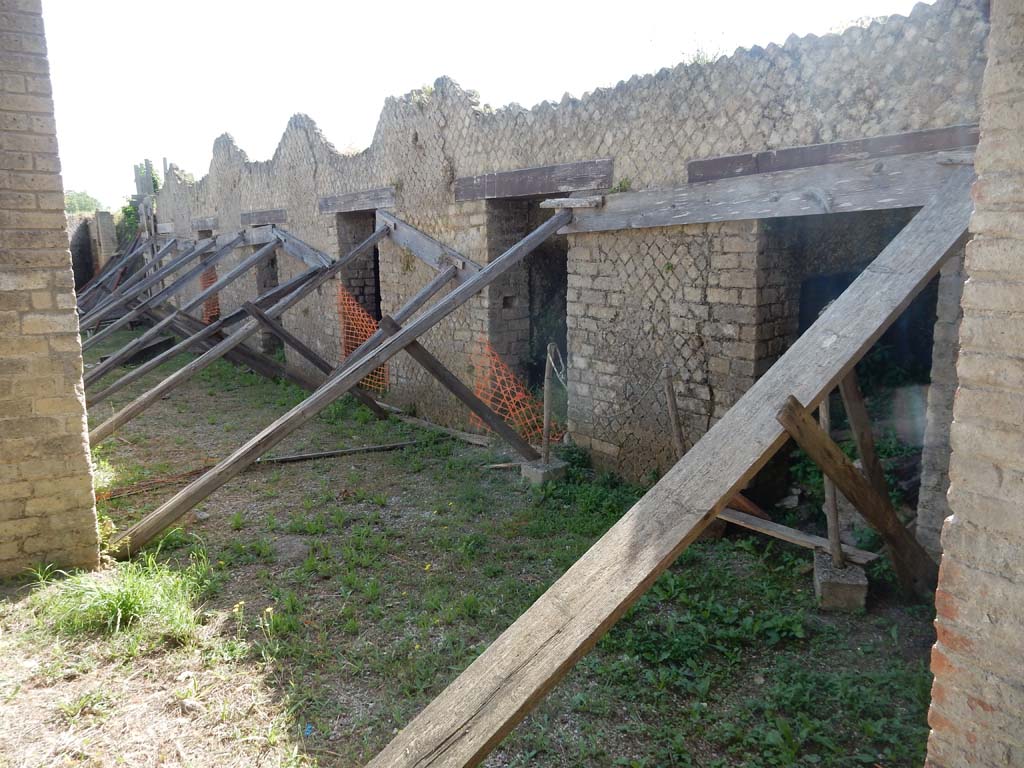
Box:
[927,0,1024,768]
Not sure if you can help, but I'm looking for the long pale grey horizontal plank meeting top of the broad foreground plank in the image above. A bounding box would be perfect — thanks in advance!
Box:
[562,152,971,233]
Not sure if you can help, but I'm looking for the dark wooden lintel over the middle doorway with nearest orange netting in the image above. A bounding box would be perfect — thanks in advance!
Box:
[455,158,611,202]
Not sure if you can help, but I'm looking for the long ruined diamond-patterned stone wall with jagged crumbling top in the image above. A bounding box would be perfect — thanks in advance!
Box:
[158,0,987,476]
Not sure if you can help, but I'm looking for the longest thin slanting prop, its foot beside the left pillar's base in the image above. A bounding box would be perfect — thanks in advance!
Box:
[114,211,572,557]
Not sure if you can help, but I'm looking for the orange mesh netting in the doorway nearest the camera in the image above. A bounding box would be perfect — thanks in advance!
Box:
[470,340,565,444]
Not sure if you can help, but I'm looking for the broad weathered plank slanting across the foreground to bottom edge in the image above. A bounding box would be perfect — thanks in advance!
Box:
[369,168,973,768]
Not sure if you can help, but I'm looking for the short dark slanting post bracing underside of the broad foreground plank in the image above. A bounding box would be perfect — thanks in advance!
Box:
[777,395,939,599]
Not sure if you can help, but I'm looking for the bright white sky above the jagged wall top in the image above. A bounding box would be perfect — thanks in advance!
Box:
[43,0,914,208]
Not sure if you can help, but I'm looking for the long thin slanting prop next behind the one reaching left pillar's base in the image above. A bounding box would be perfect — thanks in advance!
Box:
[89,227,387,445]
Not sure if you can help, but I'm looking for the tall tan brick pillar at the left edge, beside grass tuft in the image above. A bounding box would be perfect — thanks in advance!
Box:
[0,0,98,577]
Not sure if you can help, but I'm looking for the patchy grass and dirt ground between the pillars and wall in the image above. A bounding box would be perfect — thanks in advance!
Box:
[0,331,933,768]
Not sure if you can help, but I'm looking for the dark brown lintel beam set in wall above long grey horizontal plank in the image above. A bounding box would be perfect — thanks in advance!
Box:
[686,124,980,183]
